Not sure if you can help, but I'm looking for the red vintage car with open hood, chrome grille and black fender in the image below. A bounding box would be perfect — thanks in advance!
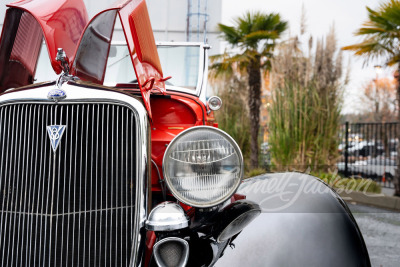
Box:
[0,0,370,266]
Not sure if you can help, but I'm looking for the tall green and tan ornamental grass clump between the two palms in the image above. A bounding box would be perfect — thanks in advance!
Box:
[269,27,344,174]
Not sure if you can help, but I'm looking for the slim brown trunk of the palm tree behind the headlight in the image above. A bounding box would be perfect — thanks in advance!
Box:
[247,58,261,168]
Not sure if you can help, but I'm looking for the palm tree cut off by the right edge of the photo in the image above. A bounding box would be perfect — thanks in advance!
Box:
[342,0,400,196]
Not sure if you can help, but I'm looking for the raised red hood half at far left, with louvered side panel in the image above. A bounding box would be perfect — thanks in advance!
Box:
[0,0,88,92]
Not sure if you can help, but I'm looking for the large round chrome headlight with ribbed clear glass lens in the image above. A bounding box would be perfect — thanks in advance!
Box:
[163,126,243,208]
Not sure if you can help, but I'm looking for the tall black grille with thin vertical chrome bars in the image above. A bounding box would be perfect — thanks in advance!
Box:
[0,103,137,266]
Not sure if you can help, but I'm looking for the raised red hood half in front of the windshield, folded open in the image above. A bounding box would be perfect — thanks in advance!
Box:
[71,0,165,118]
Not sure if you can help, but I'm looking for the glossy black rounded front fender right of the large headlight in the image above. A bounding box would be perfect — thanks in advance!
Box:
[216,173,371,267]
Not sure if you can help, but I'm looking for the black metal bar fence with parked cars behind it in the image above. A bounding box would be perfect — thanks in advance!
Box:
[337,122,400,188]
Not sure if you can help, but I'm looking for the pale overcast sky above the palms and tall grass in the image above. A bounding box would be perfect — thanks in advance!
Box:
[222,0,393,113]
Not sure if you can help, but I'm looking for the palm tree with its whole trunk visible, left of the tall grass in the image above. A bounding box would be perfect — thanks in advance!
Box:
[211,12,288,170]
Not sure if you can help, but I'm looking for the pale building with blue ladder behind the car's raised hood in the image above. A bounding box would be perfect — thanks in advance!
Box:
[0,0,222,54]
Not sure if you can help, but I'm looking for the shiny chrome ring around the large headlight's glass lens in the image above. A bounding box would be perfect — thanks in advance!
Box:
[162,126,244,208]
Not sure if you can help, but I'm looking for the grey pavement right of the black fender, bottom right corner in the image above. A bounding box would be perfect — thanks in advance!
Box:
[349,204,400,267]
